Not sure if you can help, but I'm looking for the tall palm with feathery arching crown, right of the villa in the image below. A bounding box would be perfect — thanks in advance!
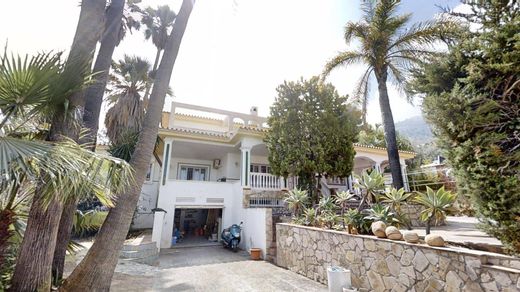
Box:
[323,0,441,189]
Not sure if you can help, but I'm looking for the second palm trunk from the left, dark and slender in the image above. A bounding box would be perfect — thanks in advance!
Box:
[52,0,125,280]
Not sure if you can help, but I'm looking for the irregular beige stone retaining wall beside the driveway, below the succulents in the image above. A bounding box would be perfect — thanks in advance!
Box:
[276,223,520,292]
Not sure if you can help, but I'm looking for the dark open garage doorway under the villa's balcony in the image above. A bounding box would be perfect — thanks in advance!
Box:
[172,208,222,248]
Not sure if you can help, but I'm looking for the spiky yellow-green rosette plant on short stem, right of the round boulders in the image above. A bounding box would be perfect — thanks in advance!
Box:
[414,187,457,234]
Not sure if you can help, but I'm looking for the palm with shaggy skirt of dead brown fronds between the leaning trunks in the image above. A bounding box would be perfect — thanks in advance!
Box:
[105,55,150,144]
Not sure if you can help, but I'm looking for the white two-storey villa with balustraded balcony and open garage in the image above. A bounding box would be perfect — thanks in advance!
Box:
[132,102,414,257]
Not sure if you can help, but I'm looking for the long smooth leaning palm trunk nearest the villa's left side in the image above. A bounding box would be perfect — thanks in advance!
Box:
[61,0,194,291]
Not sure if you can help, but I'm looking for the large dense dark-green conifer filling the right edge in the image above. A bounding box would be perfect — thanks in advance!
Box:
[411,1,520,254]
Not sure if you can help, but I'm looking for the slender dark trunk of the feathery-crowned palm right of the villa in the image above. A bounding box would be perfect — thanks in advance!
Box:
[376,69,404,189]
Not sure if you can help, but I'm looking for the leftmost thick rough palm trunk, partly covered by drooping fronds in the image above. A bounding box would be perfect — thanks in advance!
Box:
[11,0,106,291]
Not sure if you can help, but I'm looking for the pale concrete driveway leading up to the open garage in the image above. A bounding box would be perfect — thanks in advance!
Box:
[111,246,327,292]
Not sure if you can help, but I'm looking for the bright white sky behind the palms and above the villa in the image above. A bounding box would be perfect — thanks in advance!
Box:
[0,0,460,123]
